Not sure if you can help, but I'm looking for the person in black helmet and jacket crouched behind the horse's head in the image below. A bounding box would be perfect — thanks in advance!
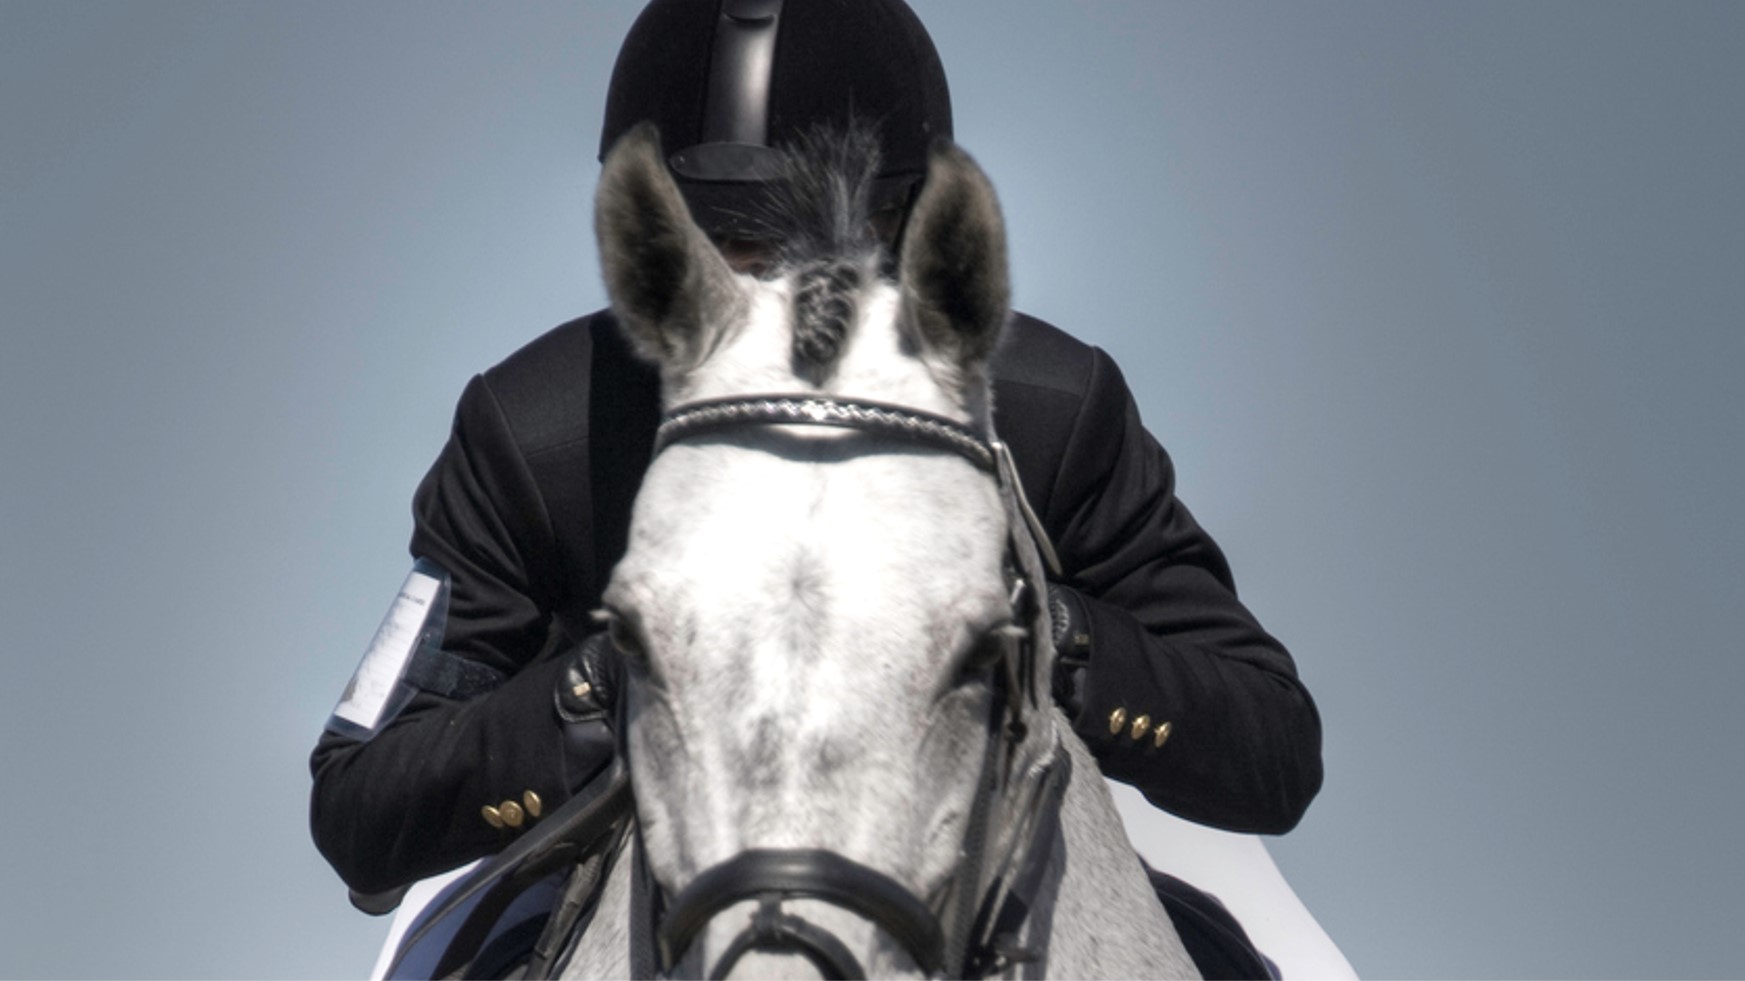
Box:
[311,0,1321,963]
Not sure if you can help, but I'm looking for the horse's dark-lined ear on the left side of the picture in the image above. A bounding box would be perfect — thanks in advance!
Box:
[593,122,740,372]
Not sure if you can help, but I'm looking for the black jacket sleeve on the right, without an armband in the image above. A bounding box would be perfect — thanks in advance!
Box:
[1045,351,1321,834]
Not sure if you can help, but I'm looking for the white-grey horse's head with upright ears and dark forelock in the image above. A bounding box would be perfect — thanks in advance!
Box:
[597,127,1047,974]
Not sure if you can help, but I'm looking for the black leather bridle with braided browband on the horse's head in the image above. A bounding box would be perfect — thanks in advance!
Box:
[637,394,1071,978]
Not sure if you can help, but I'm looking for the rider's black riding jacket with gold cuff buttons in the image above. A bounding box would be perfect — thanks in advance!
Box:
[311,312,1321,892]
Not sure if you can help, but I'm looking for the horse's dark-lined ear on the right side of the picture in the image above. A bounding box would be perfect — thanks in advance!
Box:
[899,140,1012,367]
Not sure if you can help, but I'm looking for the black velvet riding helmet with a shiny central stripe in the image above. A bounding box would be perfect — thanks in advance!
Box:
[600,0,951,239]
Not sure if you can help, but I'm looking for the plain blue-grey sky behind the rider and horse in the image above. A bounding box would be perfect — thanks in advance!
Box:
[0,0,1745,976]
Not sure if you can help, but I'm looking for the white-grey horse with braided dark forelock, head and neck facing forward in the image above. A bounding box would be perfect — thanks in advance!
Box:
[368,129,1349,978]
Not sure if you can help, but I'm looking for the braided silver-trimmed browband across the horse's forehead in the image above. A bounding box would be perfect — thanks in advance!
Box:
[654,394,998,473]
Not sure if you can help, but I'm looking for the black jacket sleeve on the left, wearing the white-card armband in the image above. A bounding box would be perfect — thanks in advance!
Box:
[311,377,607,892]
